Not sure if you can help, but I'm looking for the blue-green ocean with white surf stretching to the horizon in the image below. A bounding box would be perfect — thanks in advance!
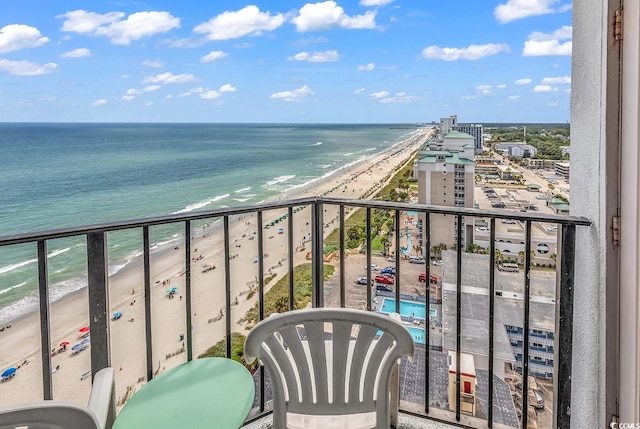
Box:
[0,123,418,324]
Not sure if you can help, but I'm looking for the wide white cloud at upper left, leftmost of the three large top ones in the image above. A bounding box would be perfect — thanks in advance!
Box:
[58,9,180,45]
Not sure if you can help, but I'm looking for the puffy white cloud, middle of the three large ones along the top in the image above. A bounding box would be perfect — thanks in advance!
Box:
[193,5,285,40]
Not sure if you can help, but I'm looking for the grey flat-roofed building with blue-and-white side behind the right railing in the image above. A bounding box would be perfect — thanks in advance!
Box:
[442,251,556,378]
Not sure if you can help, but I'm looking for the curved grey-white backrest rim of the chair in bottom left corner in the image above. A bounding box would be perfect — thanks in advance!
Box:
[0,401,100,429]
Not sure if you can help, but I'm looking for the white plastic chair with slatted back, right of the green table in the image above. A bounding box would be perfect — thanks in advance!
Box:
[244,308,415,429]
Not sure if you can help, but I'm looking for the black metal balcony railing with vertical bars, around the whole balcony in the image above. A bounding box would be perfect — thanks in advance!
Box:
[0,197,589,428]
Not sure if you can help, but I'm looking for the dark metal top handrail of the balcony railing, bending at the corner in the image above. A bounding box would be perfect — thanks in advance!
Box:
[0,197,591,246]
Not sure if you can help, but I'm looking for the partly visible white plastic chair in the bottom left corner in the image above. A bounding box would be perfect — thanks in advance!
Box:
[0,368,115,429]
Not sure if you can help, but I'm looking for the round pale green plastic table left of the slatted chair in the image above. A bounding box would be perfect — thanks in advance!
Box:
[113,358,255,429]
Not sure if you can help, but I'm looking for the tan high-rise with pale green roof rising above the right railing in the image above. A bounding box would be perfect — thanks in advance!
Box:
[413,131,475,249]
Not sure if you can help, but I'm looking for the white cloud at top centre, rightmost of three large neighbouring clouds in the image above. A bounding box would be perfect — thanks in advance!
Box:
[291,0,376,33]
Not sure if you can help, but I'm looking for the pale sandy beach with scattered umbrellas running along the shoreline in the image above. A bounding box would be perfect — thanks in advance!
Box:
[0,129,431,404]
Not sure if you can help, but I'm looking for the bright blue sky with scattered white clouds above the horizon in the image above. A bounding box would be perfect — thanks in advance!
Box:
[0,0,572,123]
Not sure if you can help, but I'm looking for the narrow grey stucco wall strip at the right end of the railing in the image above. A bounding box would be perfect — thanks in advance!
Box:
[571,0,609,428]
